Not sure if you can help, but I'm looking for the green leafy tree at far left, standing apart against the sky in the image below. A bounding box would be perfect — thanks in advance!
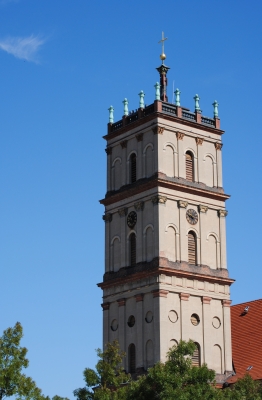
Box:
[0,322,48,400]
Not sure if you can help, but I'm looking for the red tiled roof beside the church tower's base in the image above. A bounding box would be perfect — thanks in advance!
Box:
[228,299,262,383]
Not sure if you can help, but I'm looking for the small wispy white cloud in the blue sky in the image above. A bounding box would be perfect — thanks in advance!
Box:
[0,35,45,63]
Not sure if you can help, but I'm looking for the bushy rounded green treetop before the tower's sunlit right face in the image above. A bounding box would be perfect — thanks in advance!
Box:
[126,340,221,400]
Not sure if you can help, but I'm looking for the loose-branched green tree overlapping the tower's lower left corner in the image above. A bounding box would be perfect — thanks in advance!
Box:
[73,340,131,400]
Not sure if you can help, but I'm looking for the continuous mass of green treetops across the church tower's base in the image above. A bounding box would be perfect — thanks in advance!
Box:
[76,340,262,400]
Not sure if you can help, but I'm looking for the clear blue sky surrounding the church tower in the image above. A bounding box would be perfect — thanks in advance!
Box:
[0,0,262,399]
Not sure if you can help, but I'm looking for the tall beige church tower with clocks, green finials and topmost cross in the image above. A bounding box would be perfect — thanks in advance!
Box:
[99,39,234,378]
